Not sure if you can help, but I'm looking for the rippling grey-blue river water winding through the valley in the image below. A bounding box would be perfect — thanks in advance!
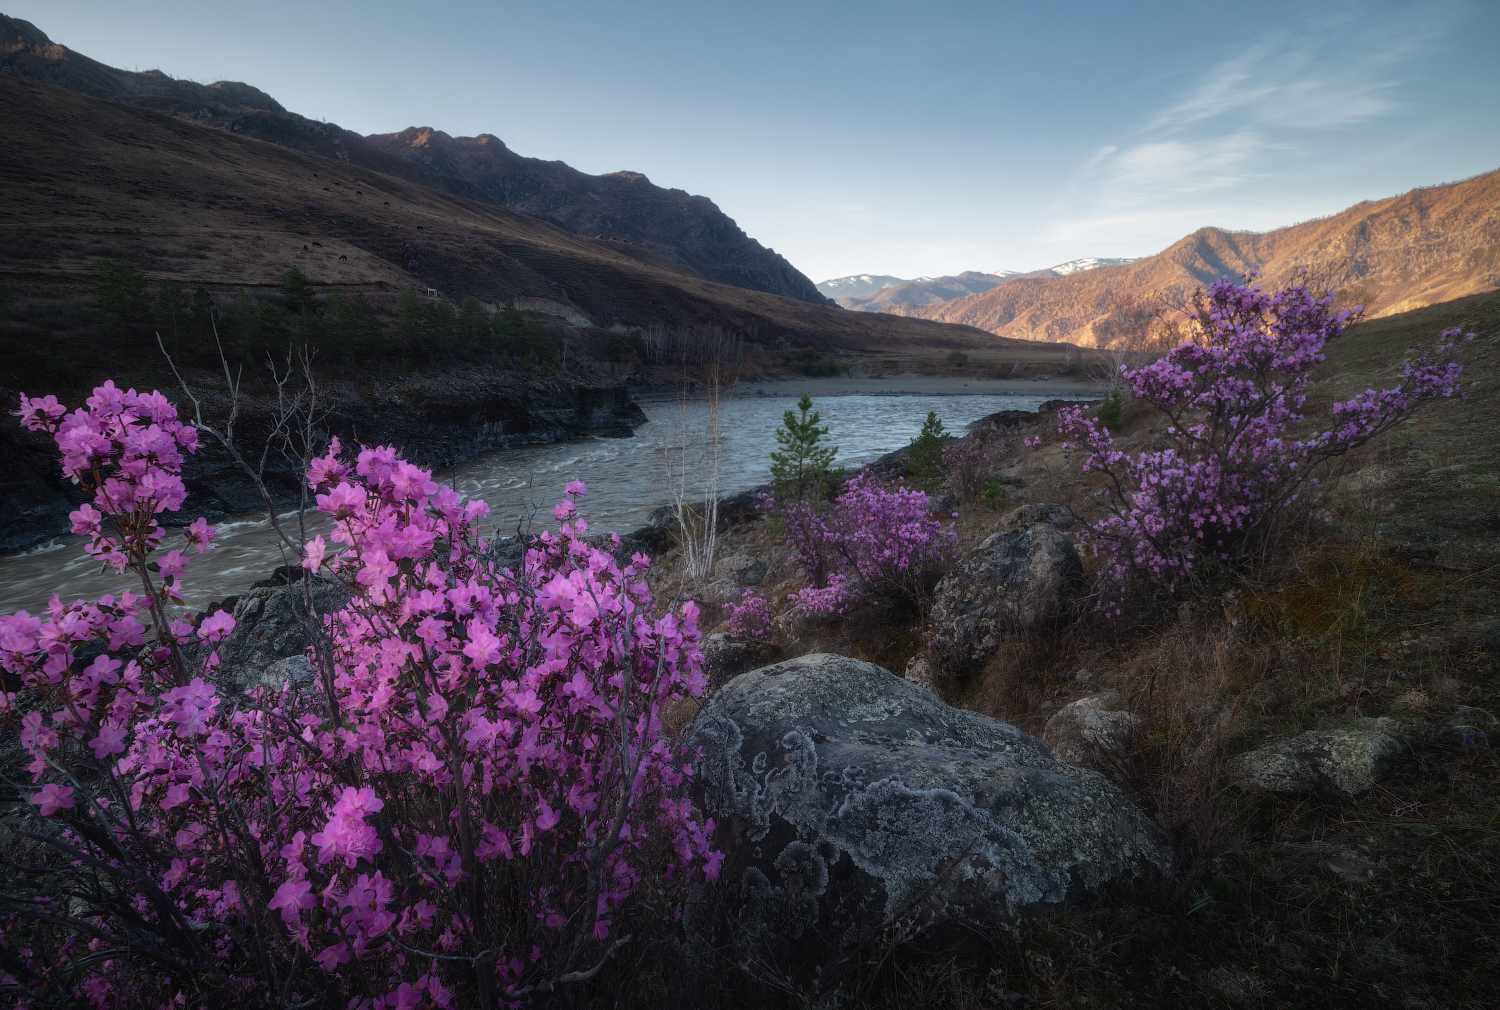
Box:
[0,383,1080,614]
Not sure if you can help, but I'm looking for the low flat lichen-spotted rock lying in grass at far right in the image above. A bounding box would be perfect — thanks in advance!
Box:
[1229,726,1401,795]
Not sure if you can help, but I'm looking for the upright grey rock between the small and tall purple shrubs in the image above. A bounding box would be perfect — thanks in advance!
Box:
[932,506,1083,677]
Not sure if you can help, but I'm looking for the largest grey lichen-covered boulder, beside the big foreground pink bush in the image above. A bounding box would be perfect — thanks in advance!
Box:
[689,654,1169,945]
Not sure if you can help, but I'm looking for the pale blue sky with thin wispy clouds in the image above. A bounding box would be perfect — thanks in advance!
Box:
[3,0,1500,281]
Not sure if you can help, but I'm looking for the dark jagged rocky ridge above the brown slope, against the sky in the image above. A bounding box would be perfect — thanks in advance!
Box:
[0,15,827,305]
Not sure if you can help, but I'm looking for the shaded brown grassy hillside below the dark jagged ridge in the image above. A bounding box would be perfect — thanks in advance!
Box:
[0,74,1032,370]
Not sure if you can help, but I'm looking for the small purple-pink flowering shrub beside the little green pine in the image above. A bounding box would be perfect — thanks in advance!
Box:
[780,473,959,615]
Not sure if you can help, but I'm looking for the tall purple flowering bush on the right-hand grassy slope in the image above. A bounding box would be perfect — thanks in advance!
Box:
[1059,278,1473,606]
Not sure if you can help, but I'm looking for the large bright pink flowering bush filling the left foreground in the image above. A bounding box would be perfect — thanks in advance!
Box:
[0,384,722,1007]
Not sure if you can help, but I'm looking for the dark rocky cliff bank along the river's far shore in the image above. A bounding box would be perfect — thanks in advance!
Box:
[0,375,647,551]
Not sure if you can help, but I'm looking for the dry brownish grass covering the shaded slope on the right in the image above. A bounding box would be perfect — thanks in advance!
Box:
[654,294,1500,1010]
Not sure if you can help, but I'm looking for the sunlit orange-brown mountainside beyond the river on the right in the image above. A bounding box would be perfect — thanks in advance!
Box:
[887,171,1500,345]
